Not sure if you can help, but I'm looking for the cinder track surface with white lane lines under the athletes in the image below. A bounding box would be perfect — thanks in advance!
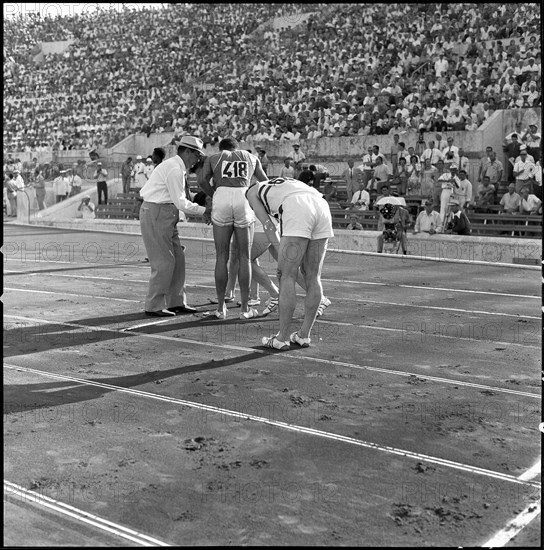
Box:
[3,225,541,547]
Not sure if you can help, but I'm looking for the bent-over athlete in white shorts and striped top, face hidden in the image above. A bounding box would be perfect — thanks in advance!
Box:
[246,178,334,350]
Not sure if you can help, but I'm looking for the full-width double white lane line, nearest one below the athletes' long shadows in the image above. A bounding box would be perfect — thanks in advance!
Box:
[4,364,540,487]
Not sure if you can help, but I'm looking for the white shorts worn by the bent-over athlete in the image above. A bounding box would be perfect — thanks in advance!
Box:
[280,194,334,241]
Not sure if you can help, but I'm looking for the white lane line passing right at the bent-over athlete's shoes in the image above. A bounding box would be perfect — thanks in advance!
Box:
[4,315,541,399]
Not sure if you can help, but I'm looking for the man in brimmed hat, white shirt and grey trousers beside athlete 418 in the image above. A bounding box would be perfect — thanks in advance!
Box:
[140,136,206,317]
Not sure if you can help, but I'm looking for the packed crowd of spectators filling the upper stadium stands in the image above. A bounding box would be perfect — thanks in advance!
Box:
[4,3,541,151]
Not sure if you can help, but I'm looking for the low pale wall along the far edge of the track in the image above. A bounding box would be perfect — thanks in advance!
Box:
[22,218,542,269]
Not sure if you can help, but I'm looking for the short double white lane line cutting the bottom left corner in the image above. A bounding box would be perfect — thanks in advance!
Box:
[4,480,170,546]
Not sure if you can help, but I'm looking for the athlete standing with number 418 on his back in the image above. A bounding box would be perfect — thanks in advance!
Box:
[198,137,267,319]
